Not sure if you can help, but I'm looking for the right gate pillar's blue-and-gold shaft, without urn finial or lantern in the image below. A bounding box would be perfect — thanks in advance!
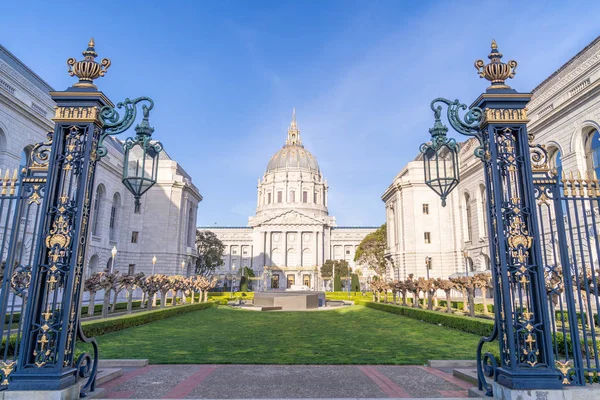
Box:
[473,88,562,389]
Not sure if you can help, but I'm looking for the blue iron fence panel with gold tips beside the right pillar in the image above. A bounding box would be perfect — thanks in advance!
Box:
[531,145,600,385]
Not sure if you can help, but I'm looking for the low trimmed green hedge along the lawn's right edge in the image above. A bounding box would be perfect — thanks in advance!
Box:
[356,301,494,336]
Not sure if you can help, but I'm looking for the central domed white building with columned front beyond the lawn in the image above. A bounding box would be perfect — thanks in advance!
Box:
[199,110,376,290]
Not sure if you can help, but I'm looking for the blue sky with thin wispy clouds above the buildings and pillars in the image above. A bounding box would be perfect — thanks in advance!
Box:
[0,0,600,226]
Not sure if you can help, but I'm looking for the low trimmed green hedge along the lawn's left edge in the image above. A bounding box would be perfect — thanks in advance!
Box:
[81,302,217,337]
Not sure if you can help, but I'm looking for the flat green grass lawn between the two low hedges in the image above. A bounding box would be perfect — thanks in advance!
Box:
[88,306,479,364]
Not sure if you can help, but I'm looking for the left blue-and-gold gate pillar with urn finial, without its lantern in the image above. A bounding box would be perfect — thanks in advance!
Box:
[6,40,113,397]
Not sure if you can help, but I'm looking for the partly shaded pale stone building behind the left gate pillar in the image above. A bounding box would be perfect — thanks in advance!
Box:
[0,42,202,275]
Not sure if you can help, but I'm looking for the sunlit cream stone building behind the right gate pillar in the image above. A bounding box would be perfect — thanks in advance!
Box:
[382,37,600,279]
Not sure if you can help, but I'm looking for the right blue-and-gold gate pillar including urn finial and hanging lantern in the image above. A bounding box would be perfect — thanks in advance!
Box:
[420,41,560,397]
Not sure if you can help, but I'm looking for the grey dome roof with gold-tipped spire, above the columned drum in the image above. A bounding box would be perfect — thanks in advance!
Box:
[267,108,321,174]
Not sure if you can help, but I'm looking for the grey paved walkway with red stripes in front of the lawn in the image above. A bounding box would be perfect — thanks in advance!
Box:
[96,365,472,399]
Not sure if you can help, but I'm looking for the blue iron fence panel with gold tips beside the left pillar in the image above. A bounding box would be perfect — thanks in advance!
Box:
[0,133,52,390]
